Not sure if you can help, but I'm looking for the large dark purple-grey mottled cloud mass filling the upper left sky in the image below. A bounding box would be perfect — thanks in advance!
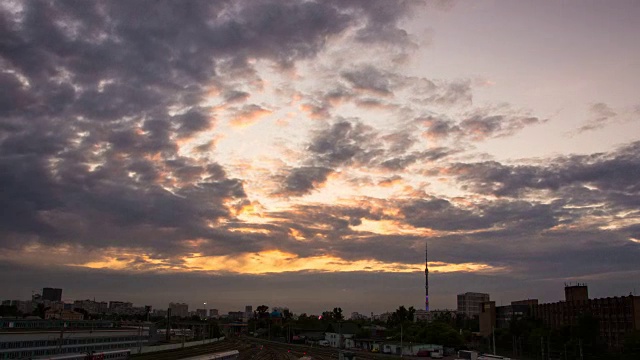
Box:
[0,1,428,252]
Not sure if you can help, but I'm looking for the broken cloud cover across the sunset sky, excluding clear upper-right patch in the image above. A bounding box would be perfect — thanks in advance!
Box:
[0,0,640,310]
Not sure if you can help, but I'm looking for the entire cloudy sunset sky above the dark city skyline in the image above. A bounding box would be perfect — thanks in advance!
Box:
[0,0,640,314]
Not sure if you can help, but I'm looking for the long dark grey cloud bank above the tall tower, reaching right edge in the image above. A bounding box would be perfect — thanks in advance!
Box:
[272,139,640,281]
